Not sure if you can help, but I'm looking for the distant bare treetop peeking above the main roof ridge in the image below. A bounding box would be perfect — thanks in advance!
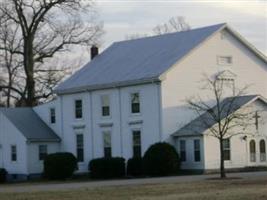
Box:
[153,16,190,35]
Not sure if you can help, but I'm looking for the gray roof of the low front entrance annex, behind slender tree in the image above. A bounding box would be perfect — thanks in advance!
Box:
[172,95,259,137]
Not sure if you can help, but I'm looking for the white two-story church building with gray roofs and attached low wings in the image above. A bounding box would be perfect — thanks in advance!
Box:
[0,24,267,178]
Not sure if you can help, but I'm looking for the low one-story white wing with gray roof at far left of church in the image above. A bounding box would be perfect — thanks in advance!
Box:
[0,108,60,180]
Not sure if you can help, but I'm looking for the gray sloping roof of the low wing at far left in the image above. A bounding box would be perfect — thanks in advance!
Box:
[0,108,60,142]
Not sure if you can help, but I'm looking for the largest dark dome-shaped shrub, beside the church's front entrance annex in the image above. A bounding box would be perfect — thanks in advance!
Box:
[143,142,180,176]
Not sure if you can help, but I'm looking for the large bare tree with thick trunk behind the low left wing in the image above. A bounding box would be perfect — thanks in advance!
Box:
[0,0,102,106]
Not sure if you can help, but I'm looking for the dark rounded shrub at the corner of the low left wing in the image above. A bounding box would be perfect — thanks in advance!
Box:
[44,152,77,179]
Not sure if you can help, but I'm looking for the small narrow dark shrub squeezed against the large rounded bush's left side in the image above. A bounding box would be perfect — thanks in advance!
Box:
[127,157,144,176]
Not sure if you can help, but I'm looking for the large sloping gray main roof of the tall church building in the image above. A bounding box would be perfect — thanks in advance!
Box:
[55,24,226,93]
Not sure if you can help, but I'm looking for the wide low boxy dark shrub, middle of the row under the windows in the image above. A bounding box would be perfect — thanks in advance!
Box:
[88,157,125,179]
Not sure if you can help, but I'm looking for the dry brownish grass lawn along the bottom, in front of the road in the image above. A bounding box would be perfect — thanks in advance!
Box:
[0,179,267,200]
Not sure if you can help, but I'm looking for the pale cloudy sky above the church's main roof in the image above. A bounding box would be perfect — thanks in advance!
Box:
[96,0,267,54]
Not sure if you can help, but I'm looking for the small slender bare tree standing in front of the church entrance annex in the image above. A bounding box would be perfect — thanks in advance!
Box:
[187,76,255,178]
